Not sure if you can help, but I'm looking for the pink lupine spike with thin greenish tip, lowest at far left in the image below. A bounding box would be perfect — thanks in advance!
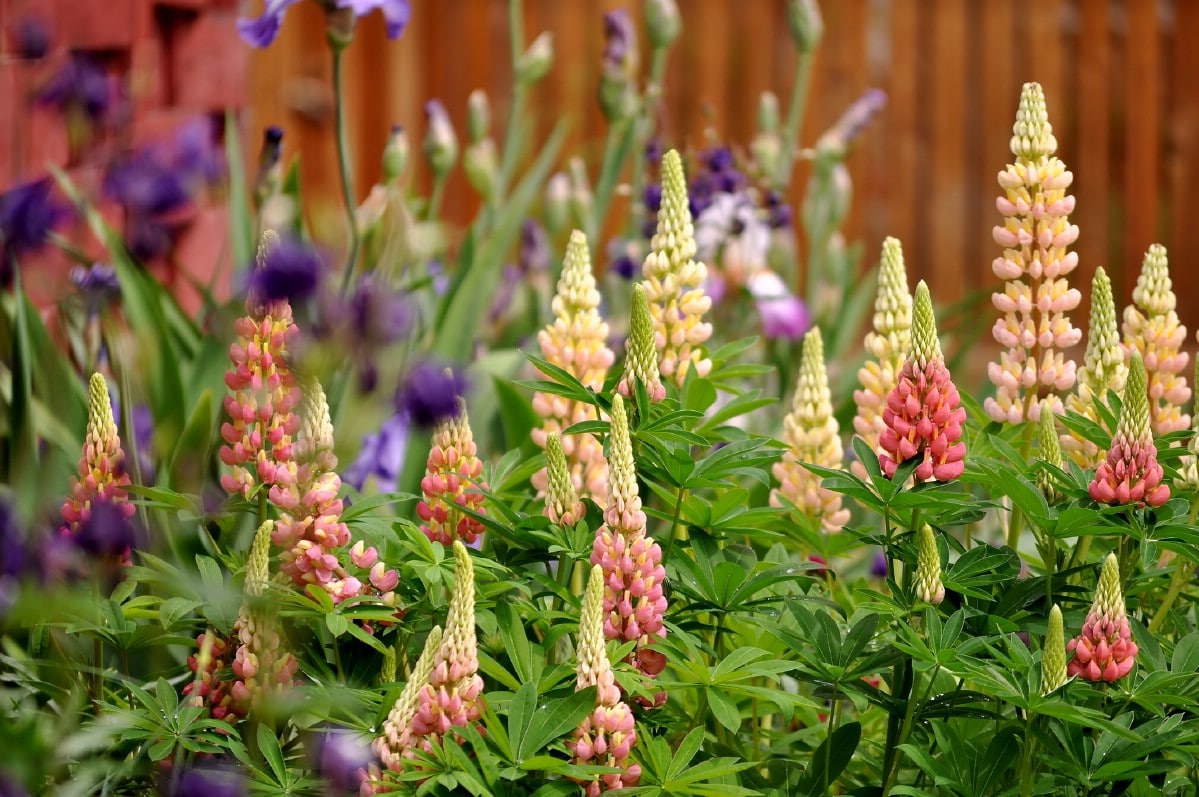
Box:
[230,520,300,711]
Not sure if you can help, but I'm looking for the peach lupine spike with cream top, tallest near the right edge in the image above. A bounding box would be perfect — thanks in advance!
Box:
[1123,243,1191,435]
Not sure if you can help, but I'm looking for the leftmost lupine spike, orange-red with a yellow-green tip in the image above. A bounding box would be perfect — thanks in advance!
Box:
[62,374,137,553]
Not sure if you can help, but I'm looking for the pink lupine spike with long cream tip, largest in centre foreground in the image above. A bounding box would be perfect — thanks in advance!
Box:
[591,394,667,676]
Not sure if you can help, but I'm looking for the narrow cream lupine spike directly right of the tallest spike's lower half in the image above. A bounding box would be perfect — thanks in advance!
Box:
[1060,266,1128,469]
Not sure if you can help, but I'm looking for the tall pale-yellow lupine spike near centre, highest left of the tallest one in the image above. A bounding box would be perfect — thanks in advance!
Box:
[641,150,712,385]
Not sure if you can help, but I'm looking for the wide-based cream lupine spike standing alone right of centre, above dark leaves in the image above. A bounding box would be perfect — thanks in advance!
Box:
[770,327,849,532]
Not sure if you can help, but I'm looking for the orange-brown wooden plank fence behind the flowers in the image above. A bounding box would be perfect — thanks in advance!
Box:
[238,0,1199,316]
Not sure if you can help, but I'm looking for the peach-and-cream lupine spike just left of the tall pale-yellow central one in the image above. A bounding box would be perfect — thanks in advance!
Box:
[532,230,615,503]
